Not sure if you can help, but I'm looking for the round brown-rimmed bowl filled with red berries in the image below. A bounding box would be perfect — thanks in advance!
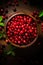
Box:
[6,13,38,48]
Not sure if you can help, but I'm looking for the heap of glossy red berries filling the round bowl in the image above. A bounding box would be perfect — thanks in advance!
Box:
[6,14,37,45]
